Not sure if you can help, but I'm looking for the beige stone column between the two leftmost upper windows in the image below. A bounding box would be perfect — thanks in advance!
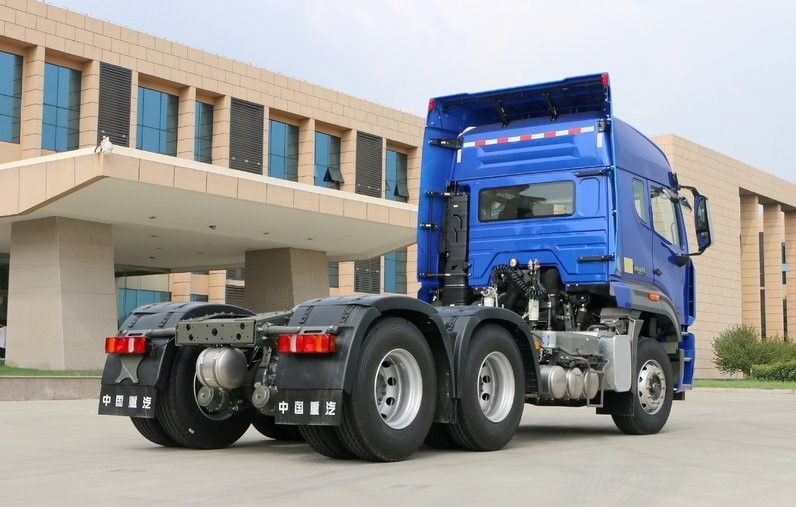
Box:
[19,46,44,158]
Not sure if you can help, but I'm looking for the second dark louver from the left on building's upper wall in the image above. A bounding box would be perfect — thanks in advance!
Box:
[229,98,265,174]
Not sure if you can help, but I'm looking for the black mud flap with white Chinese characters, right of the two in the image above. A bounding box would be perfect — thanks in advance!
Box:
[274,389,343,426]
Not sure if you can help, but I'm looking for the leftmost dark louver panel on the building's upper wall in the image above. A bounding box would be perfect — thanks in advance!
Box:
[97,62,133,146]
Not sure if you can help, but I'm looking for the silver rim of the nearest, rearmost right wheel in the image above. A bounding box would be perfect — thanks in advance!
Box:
[373,349,423,430]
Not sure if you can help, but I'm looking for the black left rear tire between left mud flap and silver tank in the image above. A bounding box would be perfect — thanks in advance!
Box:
[155,347,251,449]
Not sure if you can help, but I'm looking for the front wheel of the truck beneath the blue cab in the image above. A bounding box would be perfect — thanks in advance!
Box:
[611,338,674,435]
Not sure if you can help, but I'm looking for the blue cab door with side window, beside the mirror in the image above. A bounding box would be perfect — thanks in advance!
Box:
[649,186,691,322]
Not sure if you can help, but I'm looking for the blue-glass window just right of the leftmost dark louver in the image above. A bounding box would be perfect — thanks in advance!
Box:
[135,87,178,156]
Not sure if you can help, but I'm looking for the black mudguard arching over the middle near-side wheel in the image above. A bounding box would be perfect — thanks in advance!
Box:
[438,306,539,398]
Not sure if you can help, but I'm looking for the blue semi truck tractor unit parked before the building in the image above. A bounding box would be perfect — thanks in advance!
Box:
[99,74,711,461]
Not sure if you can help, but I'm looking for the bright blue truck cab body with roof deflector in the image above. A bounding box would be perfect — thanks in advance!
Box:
[417,74,694,332]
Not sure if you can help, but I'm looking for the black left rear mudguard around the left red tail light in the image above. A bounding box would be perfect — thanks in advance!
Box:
[102,302,254,389]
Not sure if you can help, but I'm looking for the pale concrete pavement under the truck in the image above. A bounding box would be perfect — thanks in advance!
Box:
[0,390,796,507]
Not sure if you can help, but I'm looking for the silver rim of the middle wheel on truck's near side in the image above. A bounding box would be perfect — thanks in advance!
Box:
[477,352,514,423]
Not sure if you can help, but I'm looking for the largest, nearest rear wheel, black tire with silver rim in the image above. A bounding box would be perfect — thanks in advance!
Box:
[337,317,436,461]
